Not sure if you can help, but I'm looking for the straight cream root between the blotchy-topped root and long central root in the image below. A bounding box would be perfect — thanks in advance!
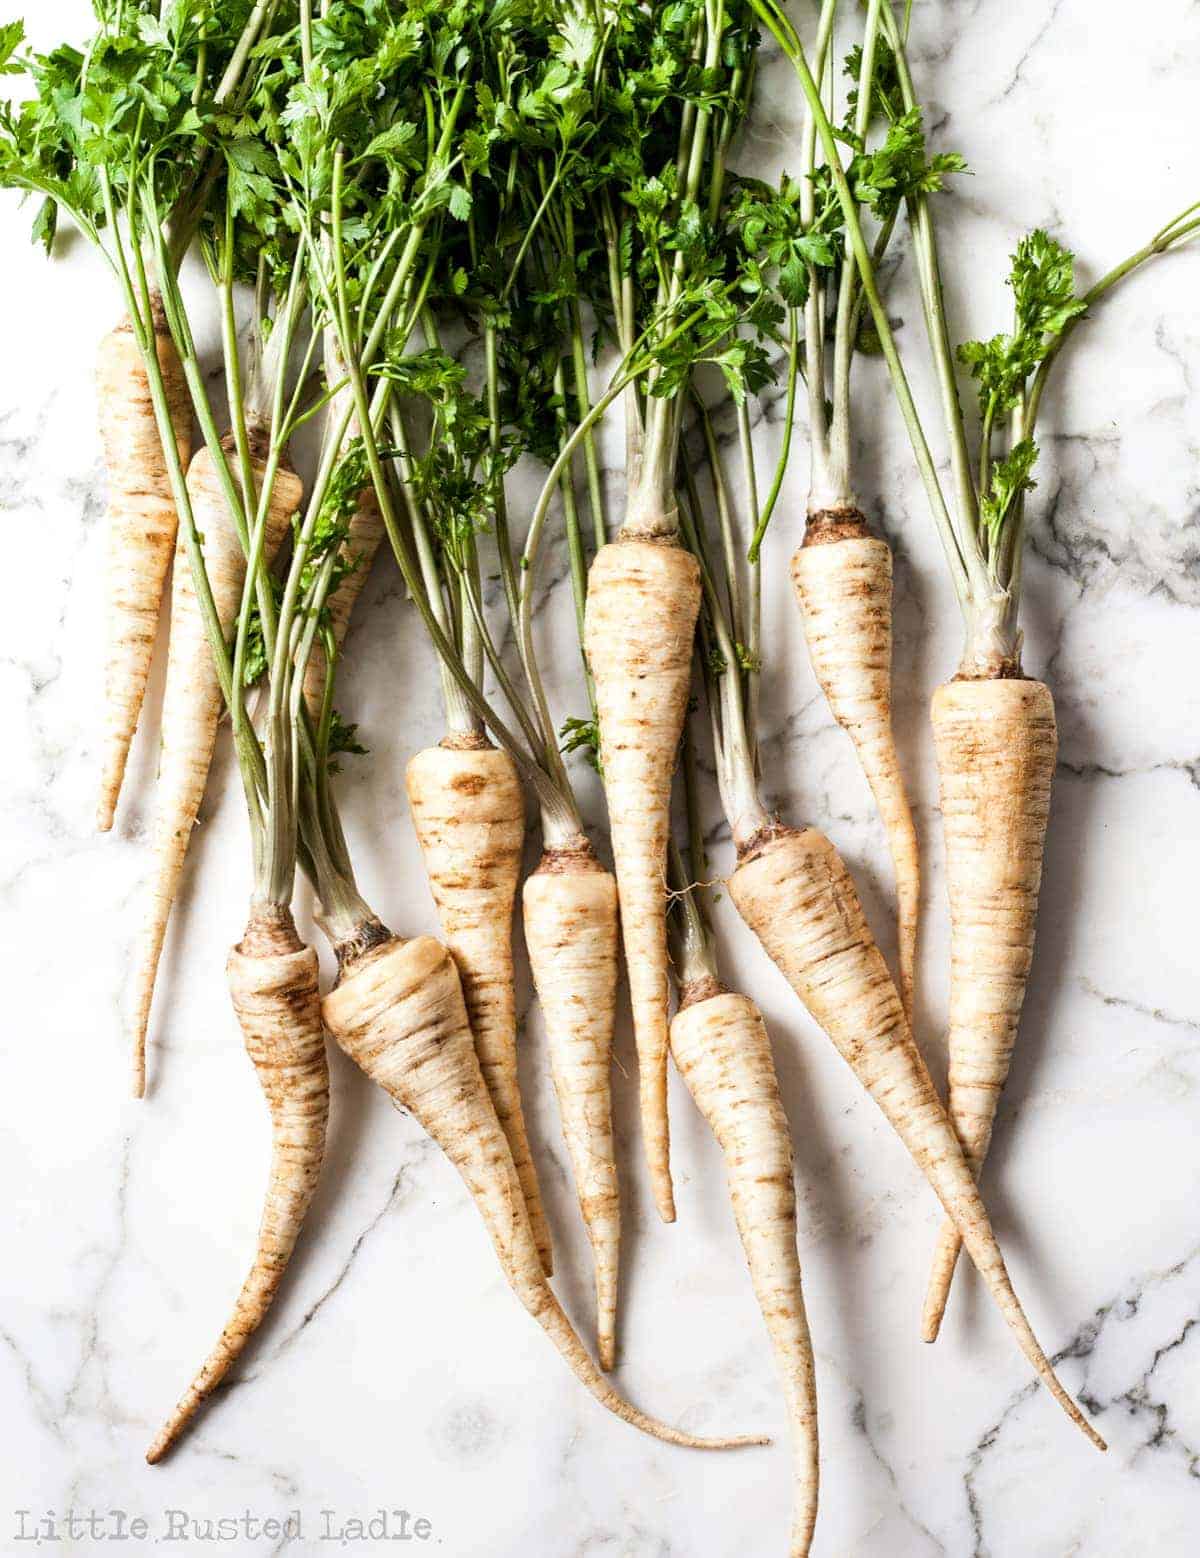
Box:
[522,848,620,1369]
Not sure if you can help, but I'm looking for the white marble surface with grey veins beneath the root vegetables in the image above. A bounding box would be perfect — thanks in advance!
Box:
[0,0,1200,1558]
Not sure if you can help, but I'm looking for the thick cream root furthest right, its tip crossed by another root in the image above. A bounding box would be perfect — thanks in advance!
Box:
[921,678,1058,1341]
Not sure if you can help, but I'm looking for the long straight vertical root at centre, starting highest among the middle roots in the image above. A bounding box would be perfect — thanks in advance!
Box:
[584,539,700,1223]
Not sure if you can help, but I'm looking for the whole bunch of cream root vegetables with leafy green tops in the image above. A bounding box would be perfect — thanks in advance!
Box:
[0,0,1200,1555]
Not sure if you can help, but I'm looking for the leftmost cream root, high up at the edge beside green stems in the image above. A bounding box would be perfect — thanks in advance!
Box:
[97,310,192,832]
